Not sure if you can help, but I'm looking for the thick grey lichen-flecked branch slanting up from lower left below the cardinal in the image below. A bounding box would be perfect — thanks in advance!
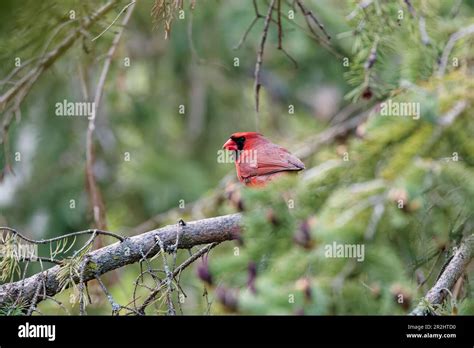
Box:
[0,214,241,307]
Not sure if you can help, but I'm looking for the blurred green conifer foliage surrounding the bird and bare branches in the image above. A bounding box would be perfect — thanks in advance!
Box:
[0,0,474,314]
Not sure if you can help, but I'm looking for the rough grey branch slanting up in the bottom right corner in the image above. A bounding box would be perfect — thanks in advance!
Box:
[410,234,474,315]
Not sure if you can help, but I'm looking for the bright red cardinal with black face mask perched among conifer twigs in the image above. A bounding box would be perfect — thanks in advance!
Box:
[223,132,304,186]
